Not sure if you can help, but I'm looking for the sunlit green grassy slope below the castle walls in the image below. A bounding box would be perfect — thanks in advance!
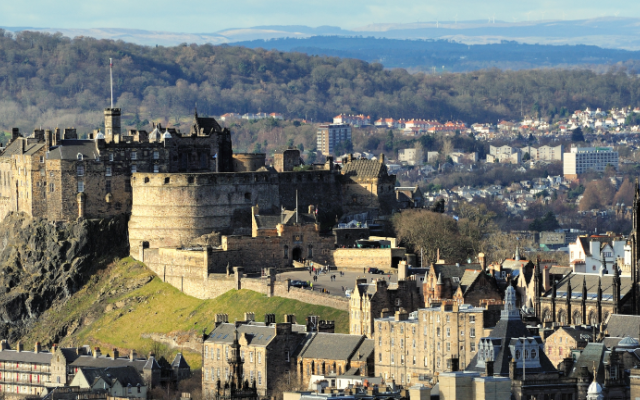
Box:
[25,258,348,368]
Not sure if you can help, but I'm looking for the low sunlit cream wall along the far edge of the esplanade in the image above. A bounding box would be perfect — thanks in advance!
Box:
[333,247,406,272]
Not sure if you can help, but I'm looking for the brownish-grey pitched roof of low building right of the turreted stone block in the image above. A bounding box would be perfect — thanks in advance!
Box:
[300,332,364,361]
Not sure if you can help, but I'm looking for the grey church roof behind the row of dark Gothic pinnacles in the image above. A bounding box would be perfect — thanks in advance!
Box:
[544,273,637,302]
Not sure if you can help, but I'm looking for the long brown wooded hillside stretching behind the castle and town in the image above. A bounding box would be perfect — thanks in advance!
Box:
[0,30,640,136]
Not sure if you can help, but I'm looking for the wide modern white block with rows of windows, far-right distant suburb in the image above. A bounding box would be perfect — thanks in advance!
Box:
[563,147,618,179]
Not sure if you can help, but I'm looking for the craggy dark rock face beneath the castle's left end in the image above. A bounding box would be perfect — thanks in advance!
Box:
[0,213,128,340]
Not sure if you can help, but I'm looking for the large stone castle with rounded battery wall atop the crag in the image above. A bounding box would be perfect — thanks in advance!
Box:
[0,108,397,285]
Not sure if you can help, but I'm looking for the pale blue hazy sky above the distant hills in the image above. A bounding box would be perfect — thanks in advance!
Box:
[0,0,640,33]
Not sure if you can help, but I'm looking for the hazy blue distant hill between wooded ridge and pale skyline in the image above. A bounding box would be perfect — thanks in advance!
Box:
[234,36,640,72]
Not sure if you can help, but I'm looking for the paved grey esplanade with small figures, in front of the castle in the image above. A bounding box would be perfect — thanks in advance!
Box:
[277,268,398,296]
